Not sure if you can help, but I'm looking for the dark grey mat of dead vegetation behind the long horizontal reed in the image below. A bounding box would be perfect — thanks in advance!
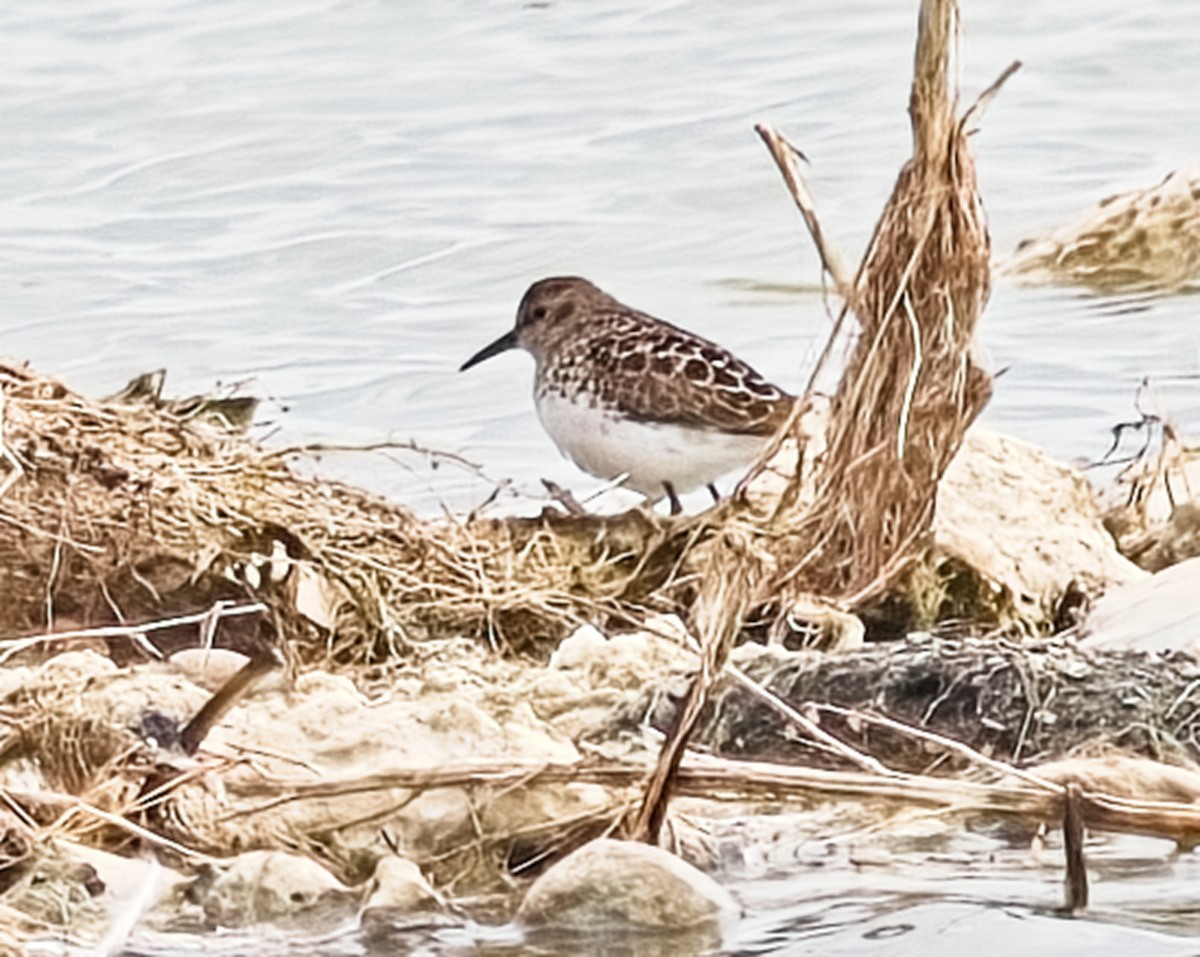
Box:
[703,637,1200,774]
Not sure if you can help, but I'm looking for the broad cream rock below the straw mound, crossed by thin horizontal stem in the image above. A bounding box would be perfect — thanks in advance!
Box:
[205,672,597,859]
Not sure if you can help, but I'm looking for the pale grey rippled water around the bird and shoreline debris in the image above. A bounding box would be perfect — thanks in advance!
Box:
[7,0,1200,953]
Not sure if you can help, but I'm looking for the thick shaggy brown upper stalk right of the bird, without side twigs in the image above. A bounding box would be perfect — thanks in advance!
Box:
[769,0,990,604]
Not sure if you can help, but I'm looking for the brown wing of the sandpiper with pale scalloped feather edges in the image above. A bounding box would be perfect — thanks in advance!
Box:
[554,309,793,435]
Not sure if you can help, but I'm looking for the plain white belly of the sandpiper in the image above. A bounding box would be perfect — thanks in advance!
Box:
[534,392,767,500]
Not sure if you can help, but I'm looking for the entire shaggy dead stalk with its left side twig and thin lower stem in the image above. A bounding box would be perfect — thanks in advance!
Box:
[634,0,1007,842]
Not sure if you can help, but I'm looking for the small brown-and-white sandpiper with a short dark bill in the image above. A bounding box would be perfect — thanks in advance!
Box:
[462,276,794,514]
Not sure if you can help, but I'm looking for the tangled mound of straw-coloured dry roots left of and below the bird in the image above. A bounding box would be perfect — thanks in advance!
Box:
[0,365,696,661]
